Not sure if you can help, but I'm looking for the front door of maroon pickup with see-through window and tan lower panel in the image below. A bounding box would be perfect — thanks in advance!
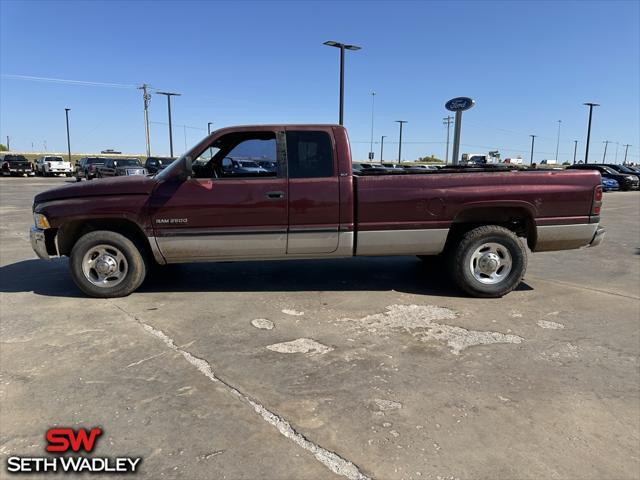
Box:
[150,129,287,262]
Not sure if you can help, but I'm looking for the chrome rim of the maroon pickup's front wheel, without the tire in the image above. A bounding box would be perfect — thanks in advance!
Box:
[82,245,129,288]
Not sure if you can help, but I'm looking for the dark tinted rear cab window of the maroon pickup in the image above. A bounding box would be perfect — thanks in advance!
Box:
[287,131,334,178]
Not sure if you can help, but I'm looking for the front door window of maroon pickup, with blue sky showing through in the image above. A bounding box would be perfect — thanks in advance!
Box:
[192,132,278,178]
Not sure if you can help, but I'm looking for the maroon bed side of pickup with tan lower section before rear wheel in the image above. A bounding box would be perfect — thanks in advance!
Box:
[353,169,600,255]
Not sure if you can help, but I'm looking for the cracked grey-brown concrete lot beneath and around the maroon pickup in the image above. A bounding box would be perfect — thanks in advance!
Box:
[0,178,640,480]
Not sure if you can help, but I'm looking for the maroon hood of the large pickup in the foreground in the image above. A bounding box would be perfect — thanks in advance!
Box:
[33,175,157,204]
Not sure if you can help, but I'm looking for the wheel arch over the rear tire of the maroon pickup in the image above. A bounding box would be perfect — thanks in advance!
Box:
[447,207,536,249]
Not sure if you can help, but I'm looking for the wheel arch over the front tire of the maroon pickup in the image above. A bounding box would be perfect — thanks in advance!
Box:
[57,218,153,258]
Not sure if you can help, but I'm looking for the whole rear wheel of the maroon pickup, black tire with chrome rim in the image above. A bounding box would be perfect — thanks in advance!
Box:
[450,225,527,298]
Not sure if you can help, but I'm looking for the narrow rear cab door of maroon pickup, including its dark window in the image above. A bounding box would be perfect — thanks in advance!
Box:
[286,127,340,255]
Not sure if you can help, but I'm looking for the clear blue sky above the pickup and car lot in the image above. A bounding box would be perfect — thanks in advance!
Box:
[0,0,640,162]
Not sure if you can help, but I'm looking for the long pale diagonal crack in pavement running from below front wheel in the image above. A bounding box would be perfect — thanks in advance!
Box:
[113,303,371,480]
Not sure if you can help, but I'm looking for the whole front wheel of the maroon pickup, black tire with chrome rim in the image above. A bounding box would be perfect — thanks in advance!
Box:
[69,230,147,298]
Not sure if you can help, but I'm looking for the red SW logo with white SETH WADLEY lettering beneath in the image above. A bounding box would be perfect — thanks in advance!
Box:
[7,427,142,473]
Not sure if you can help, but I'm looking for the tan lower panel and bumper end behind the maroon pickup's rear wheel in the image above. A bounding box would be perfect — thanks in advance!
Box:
[533,223,605,252]
